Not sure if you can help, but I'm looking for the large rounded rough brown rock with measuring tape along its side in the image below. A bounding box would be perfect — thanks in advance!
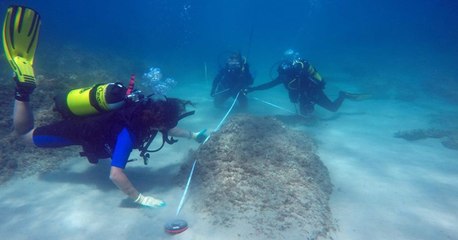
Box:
[180,115,334,239]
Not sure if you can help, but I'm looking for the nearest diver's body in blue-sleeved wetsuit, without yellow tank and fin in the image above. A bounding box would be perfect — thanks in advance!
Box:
[14,93,206,207]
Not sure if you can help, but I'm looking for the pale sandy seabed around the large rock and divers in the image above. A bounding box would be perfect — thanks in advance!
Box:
[0,78,458,240]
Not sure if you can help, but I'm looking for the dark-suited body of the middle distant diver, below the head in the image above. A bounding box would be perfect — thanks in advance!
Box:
[211,63,253,107]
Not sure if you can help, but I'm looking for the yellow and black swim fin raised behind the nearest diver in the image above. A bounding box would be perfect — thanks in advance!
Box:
[3,6,41,90]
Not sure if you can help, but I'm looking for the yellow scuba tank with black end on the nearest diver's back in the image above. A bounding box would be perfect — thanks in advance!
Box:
[54,83,127,117]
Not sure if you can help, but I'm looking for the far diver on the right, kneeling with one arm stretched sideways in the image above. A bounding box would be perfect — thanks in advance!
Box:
[244,49,367,115]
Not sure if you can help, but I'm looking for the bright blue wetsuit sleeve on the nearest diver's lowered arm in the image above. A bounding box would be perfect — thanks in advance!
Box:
[111,128,134,169]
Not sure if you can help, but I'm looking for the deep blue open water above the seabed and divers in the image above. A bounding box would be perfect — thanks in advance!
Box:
[0,0,458,85]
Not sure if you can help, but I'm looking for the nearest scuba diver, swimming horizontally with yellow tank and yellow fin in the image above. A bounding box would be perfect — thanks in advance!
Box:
[3,6,206,208]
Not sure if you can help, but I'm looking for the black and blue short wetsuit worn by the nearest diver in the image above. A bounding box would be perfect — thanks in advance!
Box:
[33,100,151,164]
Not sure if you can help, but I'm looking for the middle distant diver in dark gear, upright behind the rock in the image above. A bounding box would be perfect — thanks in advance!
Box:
[210,53,253,108]
